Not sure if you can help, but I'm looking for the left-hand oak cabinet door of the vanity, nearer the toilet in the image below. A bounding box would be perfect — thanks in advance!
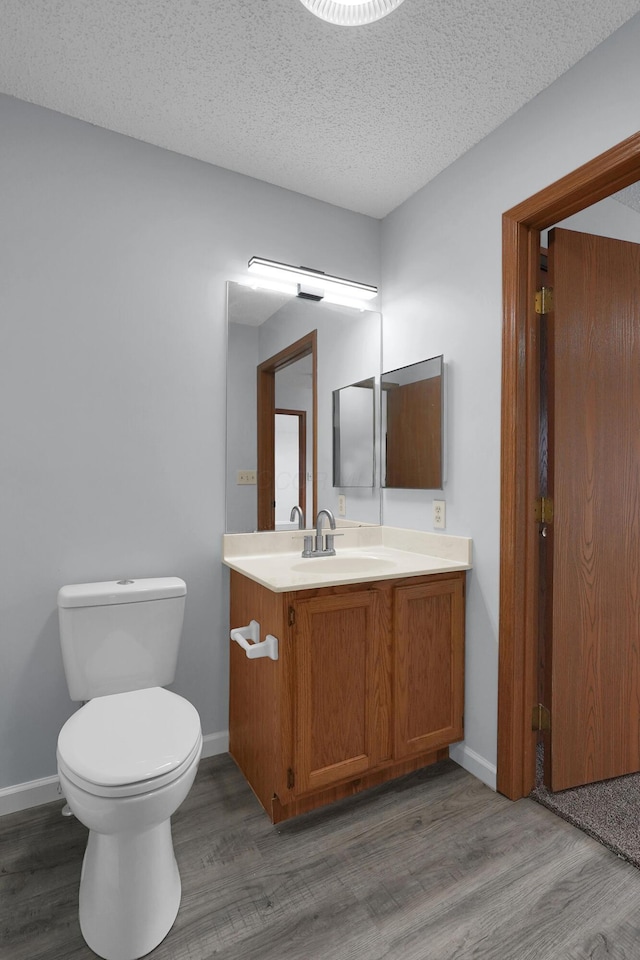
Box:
[292,590,391,794]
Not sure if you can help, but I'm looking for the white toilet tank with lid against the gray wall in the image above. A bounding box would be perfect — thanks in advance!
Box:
[58,577,187,700]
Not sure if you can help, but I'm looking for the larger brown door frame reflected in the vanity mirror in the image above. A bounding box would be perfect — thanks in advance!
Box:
[257,330,318,530]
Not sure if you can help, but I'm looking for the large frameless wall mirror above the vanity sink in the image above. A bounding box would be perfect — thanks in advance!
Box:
[226,281,382,533]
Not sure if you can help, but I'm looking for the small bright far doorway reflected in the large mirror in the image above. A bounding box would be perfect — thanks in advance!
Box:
[275,404,307,530]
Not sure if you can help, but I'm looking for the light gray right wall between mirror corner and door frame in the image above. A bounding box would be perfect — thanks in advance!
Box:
[382,9,640,783]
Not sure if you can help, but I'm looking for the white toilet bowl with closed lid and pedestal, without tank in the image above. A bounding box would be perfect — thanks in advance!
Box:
[57,687,202,960]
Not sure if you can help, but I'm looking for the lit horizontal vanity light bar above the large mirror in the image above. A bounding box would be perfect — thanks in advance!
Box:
[249,257,378,307]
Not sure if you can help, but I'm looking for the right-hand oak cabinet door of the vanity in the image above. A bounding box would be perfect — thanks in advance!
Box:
[394,578,464,759]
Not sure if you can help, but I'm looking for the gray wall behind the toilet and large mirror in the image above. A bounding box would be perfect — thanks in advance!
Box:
[0,97,380,787]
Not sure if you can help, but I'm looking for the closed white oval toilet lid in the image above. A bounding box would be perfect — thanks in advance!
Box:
[58,687,200,786]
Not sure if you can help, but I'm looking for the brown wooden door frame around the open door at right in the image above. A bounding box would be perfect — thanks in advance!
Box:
[497,133,640,800]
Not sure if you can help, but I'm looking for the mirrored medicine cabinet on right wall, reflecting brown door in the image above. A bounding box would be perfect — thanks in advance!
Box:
[381,356,444,490]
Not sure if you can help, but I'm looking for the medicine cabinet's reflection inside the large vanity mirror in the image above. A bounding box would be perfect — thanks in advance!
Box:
[333,377,376,487]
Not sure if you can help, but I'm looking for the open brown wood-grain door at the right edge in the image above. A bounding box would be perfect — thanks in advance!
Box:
[545,229,640,790]
